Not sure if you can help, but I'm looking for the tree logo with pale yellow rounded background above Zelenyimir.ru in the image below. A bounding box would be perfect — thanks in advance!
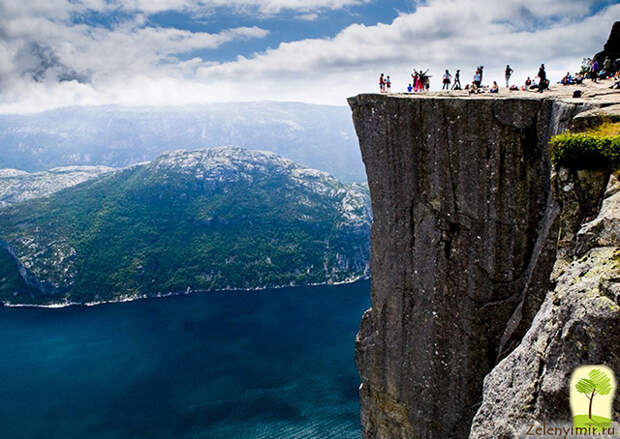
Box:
[570,366,616,433]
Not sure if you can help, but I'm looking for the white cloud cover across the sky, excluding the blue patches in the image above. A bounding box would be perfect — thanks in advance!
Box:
[0,0,620,112]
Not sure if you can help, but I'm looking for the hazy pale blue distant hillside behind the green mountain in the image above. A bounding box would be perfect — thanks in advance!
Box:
[0,102,366,182]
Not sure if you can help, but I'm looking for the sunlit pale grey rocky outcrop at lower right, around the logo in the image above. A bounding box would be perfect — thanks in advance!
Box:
[470,170,620,439]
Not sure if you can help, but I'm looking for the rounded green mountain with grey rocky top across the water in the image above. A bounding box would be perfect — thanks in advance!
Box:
[0,147,370,304]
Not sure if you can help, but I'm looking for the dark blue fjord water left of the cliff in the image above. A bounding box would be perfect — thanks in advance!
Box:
[0,282,369,439]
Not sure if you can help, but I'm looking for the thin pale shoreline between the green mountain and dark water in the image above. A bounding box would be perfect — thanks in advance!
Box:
[0,274,370,309]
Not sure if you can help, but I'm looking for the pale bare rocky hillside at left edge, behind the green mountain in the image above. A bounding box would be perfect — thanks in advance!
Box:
[0,166,115,207]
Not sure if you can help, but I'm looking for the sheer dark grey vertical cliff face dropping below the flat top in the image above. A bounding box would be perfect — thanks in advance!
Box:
[349,95,582,439]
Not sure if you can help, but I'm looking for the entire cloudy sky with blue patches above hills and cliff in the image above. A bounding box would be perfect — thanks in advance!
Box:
[0,0,620,113]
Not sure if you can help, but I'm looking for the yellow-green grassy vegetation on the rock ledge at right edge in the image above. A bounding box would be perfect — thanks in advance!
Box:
[550,121,620,169]
